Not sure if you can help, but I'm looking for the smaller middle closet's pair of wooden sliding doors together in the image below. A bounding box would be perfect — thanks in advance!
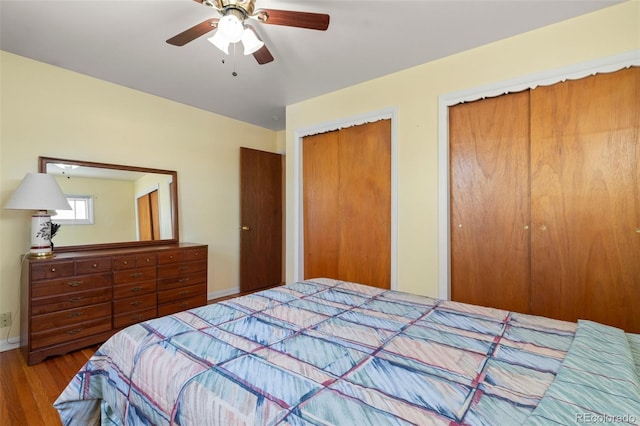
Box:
[302,120,391,288]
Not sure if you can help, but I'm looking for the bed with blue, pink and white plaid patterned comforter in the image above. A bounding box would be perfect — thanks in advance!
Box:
[54,279,640,426]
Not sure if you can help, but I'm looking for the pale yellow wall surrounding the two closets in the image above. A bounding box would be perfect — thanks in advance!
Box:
[286,1,640,296]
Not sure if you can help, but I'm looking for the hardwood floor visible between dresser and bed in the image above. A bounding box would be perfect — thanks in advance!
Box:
[0,346,98,426]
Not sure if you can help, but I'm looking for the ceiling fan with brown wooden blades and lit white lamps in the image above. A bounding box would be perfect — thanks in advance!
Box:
[167,0,329,65]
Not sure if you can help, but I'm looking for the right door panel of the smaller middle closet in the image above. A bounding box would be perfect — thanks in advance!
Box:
[338,120,391,288]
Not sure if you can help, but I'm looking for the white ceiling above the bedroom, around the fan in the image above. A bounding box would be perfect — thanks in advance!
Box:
[0,0,620,130]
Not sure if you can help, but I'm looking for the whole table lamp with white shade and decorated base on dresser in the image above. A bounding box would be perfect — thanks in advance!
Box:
[4,173,71,259]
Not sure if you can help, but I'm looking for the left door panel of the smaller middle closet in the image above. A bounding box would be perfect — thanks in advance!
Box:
[302,131,341,279]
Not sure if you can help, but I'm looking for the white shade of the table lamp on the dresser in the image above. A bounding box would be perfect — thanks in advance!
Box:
[4,173,71,210]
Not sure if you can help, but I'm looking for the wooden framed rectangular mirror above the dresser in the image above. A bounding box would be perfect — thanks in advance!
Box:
[38,157,179,252]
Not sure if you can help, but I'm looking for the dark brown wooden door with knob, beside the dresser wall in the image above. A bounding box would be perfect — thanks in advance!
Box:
[239,148,283,293]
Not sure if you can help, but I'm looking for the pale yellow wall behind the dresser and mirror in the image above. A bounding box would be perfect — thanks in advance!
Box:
[0,52,282,343]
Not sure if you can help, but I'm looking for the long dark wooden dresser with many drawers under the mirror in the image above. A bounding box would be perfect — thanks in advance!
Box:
[20,243,207,365]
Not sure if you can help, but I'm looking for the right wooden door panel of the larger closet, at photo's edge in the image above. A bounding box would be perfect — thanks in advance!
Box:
[531,67,640,333]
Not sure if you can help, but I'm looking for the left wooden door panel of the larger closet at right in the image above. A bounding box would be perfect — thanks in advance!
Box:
[449,91,530,313]
